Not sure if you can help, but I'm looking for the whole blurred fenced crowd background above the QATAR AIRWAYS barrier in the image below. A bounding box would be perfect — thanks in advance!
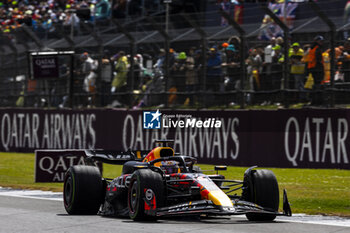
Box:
[0,0,350,109]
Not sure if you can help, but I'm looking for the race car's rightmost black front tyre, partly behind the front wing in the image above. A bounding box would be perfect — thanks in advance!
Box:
[245,169,279,221]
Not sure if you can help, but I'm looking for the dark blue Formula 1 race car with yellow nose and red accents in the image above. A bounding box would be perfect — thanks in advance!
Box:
[63,140,292,221]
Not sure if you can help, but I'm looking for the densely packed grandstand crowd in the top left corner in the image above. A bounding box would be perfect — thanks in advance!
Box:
[0,0,111,33]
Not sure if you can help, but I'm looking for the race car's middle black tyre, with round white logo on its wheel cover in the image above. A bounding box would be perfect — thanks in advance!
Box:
[128,169,164,221]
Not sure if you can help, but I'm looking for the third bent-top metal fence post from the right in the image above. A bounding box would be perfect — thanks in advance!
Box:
[220,9,247,109]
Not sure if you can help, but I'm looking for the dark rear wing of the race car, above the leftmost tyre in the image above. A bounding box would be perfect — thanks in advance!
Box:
[84,150,149,165]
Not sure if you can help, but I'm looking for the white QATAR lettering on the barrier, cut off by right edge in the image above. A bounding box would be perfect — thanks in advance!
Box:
[284,117,349,167]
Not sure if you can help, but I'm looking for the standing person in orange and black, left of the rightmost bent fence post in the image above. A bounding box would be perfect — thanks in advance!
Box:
[308,36,324,106]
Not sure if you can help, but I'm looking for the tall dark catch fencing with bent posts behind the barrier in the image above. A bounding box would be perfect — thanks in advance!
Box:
[0,0,350,108]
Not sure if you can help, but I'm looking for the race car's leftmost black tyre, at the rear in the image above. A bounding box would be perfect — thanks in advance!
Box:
[63,165,104,214]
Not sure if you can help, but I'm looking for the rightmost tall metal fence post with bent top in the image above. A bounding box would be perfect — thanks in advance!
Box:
[308,0,337,107]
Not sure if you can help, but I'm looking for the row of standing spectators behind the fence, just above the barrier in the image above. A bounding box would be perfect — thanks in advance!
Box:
[70,33,350,107]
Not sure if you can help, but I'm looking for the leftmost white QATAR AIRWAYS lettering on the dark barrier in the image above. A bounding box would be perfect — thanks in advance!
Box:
[0,113,96,151]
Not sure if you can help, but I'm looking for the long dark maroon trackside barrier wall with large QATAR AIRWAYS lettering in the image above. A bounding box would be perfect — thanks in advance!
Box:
[0,108,350,169]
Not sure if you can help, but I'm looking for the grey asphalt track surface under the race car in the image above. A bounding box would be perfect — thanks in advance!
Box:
[0,196,350,233]
